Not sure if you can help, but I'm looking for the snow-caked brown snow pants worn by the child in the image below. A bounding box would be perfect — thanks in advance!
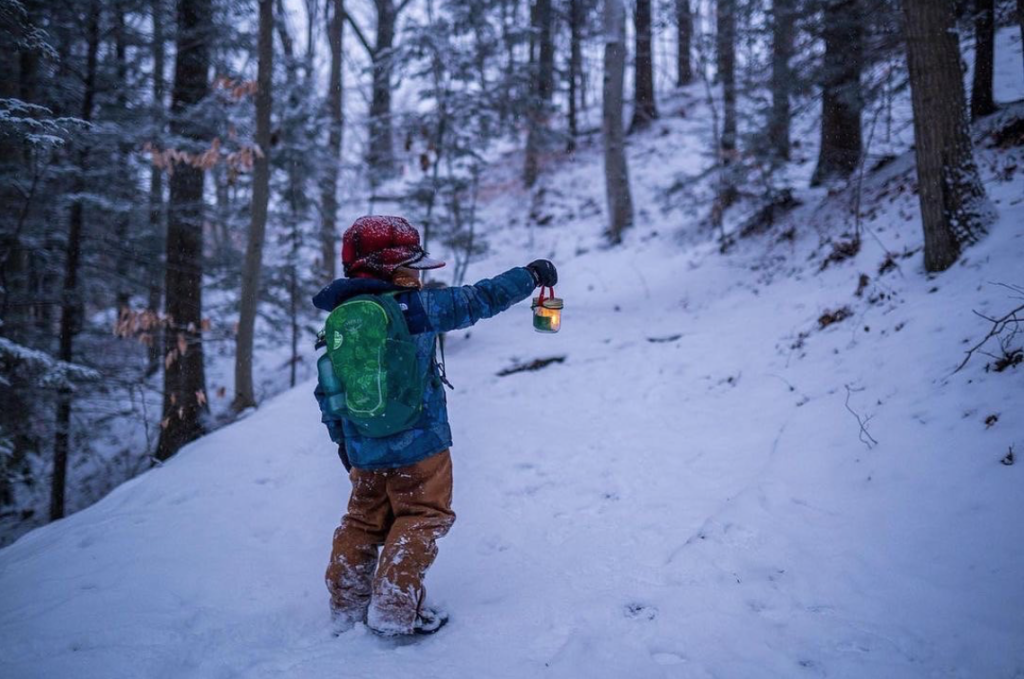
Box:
[327,451,455,634]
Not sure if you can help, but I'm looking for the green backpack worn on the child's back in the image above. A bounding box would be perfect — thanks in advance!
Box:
[324,293,428,438]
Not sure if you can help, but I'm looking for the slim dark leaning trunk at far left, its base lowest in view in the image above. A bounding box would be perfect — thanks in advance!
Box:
[50,0,100,521]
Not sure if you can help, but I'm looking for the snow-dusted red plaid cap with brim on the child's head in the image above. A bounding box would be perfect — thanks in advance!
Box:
[341,215,444,280]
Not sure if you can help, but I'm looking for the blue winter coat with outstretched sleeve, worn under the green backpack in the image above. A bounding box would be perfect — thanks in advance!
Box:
[313,267,535,469]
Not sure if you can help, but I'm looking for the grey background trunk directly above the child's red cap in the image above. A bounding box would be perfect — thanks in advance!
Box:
[367,0,398,185]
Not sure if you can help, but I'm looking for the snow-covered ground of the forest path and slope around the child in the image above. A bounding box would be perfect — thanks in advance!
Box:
[0,27,1024,679]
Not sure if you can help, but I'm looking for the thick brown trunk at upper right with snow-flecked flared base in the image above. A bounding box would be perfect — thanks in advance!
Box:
[903,0,994,271]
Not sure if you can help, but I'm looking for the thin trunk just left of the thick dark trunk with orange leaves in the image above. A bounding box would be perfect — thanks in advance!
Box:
[145,0,166,376]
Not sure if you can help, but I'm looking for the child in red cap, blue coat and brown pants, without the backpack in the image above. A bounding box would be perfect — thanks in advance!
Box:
[313,216,558,635]
